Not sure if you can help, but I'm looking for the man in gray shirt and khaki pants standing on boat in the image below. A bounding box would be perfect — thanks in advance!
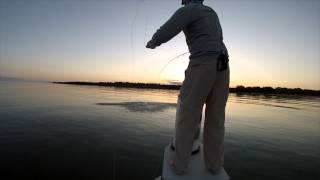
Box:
[146,0,229,175]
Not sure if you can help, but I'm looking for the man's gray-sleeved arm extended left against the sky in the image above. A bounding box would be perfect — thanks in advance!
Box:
[147,7,191,49]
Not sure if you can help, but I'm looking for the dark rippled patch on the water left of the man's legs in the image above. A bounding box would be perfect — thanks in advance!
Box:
[97,102,177,112]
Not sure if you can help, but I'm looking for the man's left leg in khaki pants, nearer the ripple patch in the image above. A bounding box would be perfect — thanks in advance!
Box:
[172,65,215,174]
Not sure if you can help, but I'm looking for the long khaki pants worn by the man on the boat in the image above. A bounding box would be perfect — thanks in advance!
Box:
[172,56,230,174]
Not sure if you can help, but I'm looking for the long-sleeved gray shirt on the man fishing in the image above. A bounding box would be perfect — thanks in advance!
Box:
[152,3,227,61]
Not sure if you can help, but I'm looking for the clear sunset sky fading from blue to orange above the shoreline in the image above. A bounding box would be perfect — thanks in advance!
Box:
[0,0,320,90]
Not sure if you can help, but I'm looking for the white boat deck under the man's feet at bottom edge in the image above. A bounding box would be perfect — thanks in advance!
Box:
[156,144,230,180]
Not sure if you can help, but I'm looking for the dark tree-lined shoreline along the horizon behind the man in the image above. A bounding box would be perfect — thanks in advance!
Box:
[51,81,320,97]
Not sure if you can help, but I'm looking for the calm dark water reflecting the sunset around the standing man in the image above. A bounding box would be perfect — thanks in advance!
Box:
[0,82,320,180]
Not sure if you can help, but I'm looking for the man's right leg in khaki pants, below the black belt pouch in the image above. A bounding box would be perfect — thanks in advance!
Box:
[203,69,229,173]
